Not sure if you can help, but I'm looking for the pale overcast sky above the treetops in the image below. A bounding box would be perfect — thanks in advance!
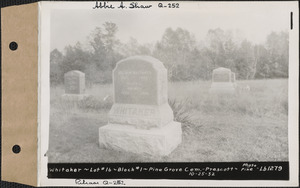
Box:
[50,2,290,51]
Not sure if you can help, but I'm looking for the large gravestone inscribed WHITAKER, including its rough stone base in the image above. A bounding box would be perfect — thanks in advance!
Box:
[99,56,182,156]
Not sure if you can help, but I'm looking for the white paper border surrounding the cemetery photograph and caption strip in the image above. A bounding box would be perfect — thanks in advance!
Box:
[38,1,299,187]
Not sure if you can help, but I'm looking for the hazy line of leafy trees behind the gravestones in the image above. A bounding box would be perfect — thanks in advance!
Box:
[50,22,289,85]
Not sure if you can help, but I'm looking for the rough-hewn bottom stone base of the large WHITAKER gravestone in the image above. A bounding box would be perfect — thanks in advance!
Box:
[99,121,182,156]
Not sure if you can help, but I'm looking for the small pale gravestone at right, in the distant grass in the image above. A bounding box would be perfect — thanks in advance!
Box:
[209,67,235,94]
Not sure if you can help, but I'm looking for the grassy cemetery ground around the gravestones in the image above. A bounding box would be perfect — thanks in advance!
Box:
[48,79,288,162]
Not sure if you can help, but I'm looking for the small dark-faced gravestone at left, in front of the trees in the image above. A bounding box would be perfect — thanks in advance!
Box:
[63,70,87,99]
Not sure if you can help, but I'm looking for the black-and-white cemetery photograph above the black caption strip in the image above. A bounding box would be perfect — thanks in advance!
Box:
[47,6,289,163]
